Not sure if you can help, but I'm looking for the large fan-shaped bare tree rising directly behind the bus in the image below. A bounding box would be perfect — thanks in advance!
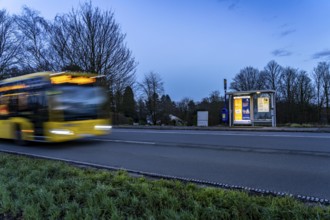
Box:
[51,3,136,94]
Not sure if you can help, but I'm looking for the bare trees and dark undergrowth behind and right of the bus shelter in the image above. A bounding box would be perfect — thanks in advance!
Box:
[230,60,330,124]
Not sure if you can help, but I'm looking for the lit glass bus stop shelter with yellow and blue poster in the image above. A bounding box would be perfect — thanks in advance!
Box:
[227,90,276,127]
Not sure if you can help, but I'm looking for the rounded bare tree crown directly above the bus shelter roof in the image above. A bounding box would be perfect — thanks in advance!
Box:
[230,66,265,91]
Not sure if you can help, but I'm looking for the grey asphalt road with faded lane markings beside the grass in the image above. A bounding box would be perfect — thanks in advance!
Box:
[0,129,330,199]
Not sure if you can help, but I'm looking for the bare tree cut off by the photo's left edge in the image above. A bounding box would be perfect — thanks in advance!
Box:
[0,10,21,78]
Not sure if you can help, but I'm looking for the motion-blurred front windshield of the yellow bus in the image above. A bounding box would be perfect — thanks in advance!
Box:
[50,85,106,121]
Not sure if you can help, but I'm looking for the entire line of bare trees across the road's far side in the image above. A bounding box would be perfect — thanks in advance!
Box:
[0,3,330,125]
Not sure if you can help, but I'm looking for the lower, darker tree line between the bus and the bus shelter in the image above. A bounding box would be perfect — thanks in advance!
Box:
[113,72,225,126]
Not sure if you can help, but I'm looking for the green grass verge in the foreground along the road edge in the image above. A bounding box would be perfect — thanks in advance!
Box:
[0,153,330,220]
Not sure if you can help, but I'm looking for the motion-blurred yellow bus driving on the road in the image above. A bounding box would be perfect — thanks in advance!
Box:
[0,72,112,144]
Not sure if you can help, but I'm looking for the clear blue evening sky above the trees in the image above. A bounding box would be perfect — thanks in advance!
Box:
[0,0,330,101]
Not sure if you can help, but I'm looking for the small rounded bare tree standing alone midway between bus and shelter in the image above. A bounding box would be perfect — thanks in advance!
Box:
[139,72,164,124]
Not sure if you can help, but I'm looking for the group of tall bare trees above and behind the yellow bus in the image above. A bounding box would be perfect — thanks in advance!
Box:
[0,3,137,115]
